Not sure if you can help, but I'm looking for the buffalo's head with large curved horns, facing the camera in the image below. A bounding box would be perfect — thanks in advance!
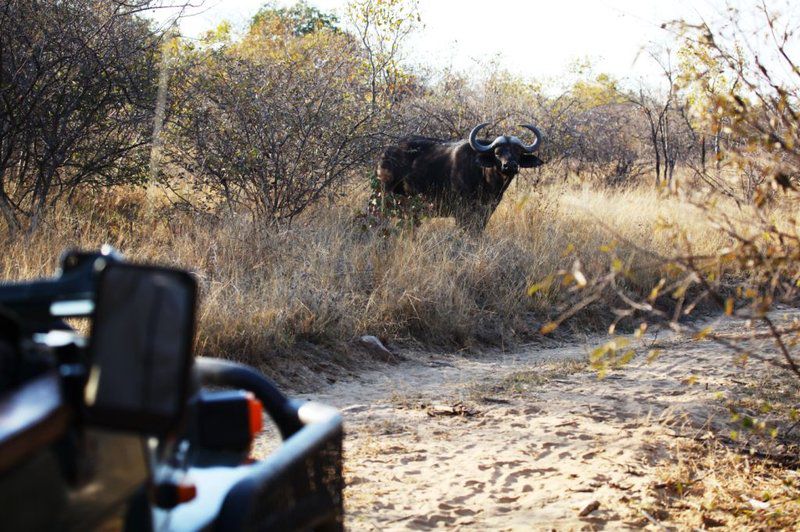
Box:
[469,122,544,177]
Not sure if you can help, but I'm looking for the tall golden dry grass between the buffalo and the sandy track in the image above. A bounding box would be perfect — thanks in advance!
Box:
[0,181,721,382]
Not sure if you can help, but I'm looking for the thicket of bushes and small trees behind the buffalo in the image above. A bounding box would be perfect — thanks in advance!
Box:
[0,0,744,235]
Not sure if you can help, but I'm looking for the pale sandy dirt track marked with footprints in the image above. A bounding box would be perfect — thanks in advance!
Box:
[296,314,788,530]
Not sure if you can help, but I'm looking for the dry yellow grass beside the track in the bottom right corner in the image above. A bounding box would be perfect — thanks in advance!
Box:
[642,352,800,530]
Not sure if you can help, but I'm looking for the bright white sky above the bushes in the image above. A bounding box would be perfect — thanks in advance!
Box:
[147,0,772,80]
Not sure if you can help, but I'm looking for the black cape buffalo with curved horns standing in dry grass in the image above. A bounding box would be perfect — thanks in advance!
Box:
[378,123,544,230]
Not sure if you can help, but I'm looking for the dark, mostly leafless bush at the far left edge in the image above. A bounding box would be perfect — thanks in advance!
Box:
[0,0,160,233]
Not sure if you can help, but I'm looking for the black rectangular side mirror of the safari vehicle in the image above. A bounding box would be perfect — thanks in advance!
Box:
[84,263,197,435]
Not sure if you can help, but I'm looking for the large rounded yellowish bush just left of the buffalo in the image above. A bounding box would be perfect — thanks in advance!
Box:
[163,15,384,225]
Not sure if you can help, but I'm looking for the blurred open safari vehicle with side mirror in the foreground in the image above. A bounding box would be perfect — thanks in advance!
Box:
[0,248,343,531]
